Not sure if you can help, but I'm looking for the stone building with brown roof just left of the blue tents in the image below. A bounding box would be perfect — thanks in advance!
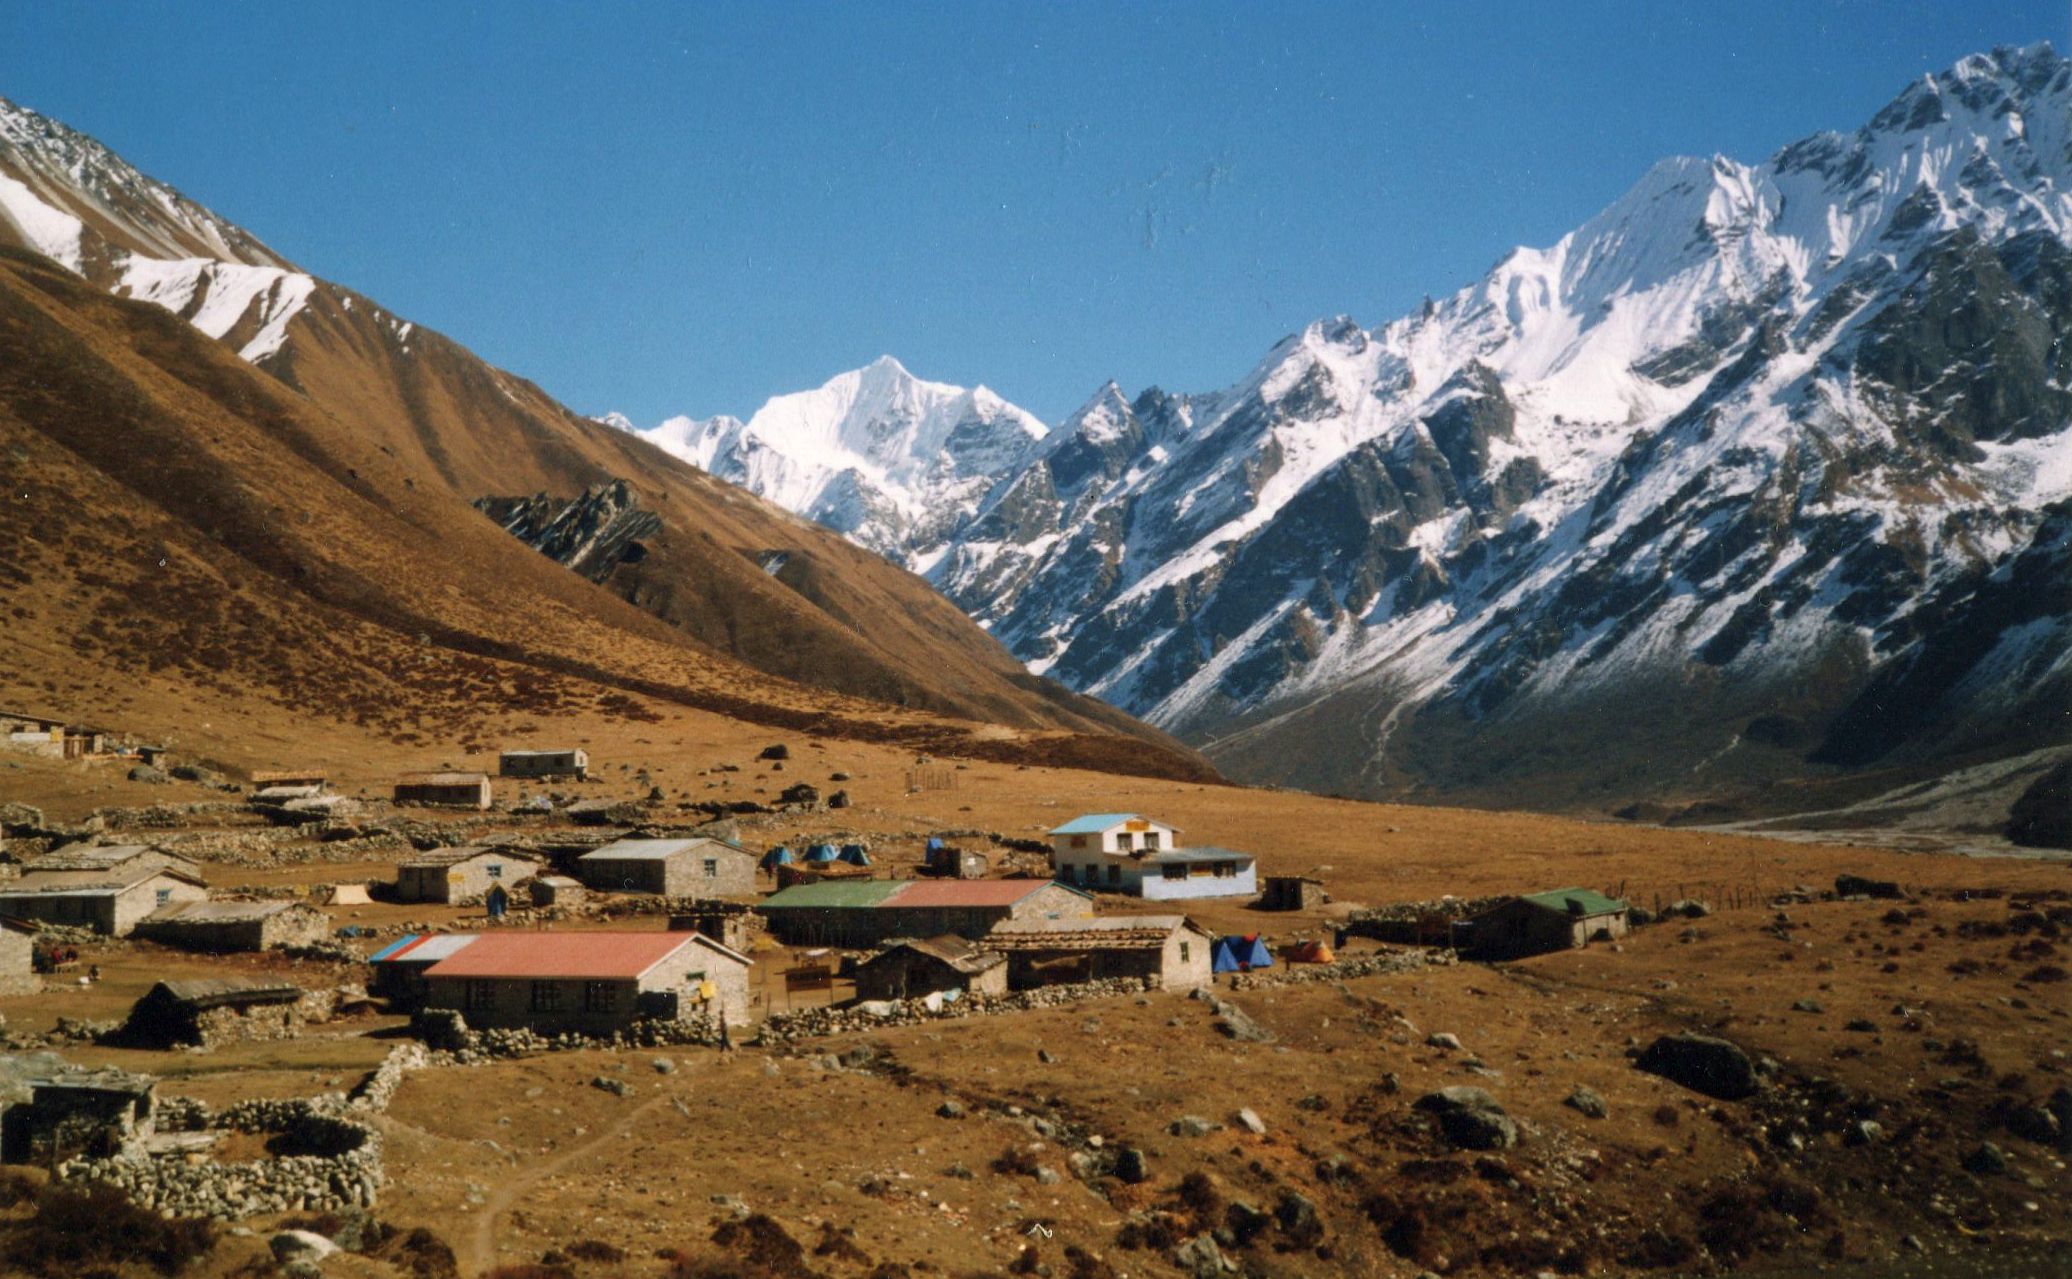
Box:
[982,914,1214,991]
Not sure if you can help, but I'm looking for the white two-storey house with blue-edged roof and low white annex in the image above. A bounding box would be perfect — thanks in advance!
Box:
[1051,813,1260,902]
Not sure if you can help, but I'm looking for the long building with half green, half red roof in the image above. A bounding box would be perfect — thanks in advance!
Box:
[756,879,1094,949]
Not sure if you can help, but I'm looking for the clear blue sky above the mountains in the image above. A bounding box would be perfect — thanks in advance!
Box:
[0,0,2068,425]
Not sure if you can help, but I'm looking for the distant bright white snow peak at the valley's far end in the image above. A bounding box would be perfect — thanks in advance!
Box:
[599,354,1044,564]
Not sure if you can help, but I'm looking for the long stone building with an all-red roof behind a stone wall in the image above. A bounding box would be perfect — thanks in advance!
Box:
[425,933,754,1034]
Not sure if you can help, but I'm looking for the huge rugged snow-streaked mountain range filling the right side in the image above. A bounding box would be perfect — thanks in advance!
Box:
[920,46,2072,802]
